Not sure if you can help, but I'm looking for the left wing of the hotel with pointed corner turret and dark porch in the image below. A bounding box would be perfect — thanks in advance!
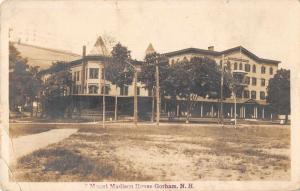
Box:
[64,37,151,118]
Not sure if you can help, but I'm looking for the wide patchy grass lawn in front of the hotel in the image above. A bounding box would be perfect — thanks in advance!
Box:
[12,125,290,181]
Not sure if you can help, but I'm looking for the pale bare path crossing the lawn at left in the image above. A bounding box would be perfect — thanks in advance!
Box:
[10,129,78,164]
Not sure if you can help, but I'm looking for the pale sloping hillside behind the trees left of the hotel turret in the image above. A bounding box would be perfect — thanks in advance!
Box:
[13,42,81,69]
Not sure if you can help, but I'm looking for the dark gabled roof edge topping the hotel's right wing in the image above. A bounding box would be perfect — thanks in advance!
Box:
[164,46,280,64]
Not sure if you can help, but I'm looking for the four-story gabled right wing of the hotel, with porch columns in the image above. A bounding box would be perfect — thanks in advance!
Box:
[164,46,280,118]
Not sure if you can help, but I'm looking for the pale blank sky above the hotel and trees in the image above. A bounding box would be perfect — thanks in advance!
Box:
[2,0,300,68]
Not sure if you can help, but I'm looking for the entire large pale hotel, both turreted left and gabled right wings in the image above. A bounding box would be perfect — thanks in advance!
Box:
[39,37,280,119]
